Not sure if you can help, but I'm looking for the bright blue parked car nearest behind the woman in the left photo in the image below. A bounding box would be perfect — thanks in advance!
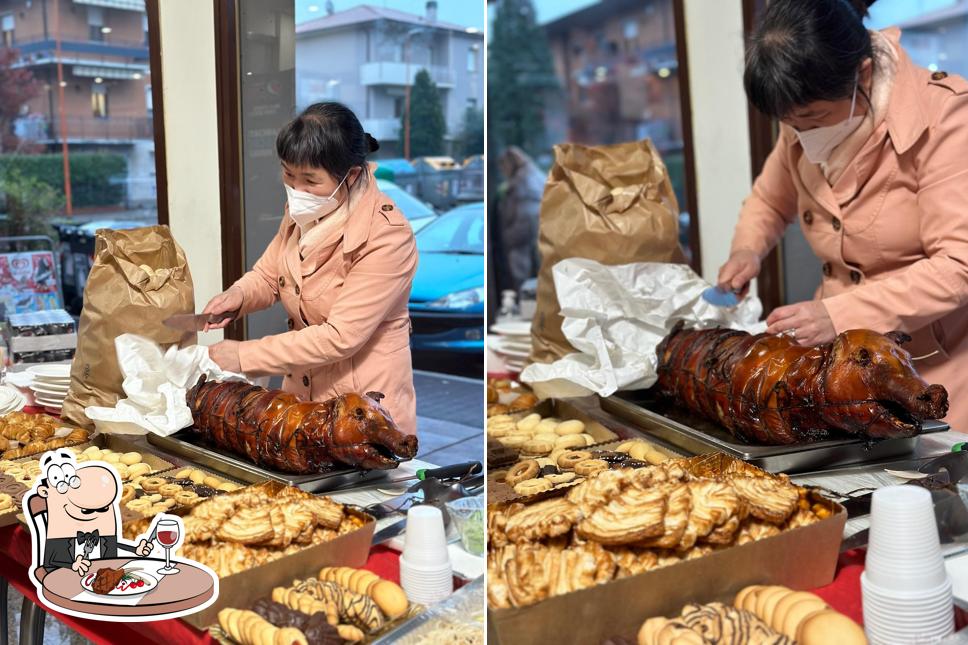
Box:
[410,202,485,354]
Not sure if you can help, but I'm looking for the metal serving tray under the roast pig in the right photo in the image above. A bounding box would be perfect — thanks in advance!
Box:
[601,390,949,473]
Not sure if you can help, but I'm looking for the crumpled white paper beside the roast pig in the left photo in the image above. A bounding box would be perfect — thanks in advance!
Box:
[84,334,248,436]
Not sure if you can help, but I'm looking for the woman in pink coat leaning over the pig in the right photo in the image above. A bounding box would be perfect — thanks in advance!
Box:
[718,0,968,431]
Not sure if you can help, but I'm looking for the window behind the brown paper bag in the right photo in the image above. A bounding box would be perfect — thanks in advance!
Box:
[487,0,698,302]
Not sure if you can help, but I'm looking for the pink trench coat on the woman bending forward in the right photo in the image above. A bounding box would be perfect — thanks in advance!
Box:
[732,36,968,432]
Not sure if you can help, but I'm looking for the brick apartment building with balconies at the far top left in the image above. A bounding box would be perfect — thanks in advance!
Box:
[0,0,156,206]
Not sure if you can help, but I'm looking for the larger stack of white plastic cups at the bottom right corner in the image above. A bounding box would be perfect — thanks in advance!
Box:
[861,485,954,645]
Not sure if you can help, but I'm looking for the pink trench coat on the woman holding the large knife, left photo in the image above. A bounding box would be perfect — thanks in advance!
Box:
[235,178,417,434]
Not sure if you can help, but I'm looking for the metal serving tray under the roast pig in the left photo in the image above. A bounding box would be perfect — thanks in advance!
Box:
[148,430,391,493]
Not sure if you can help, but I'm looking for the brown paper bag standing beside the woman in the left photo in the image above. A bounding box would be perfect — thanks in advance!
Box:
[61,226,198,428]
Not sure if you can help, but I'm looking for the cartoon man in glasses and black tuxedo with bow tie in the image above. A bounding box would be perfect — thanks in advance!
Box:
[37,451,151,576]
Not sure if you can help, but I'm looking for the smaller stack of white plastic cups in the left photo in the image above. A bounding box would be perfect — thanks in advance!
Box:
[400,505,454,605]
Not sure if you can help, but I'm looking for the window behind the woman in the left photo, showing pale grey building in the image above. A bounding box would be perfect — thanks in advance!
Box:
[233,0,485,338]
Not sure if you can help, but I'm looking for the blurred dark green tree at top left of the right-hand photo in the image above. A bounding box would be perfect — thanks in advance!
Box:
[487,0,558,156]
